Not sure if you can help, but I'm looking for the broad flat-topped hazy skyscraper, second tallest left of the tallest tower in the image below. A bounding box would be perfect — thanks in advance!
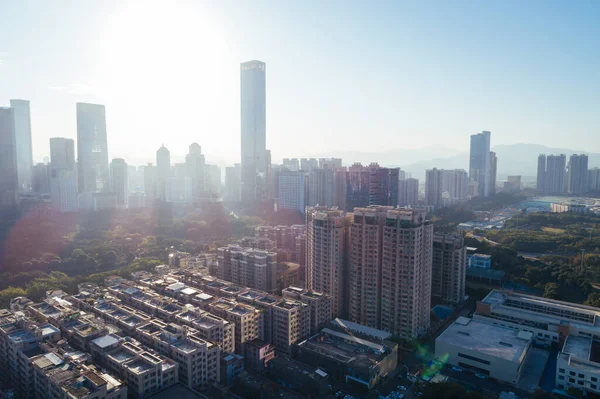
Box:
[77,103,109,193]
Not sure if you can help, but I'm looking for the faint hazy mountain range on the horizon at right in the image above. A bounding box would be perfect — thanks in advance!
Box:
[314,143,600,179]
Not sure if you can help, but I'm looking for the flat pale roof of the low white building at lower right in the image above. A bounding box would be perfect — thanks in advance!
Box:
[435,317,531,362]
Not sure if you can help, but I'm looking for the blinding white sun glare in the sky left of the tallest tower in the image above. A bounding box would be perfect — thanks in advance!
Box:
[97,2,236,161]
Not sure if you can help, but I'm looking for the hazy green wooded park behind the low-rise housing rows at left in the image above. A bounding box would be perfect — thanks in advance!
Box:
[0,203,270,306]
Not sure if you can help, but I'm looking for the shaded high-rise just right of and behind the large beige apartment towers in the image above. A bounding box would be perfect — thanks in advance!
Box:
[431,233,467,303]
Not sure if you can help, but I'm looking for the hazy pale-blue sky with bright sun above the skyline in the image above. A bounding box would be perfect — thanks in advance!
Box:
[0,0,600,163]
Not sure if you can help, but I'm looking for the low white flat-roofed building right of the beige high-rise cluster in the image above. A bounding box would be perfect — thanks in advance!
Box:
[435,317,533,384]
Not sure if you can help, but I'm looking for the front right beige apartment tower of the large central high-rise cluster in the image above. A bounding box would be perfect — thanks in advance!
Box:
[381,208,433,339]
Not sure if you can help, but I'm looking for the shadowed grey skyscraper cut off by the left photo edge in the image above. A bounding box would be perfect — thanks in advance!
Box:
[0,107,19,208]
